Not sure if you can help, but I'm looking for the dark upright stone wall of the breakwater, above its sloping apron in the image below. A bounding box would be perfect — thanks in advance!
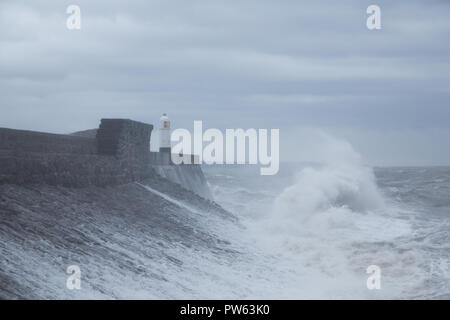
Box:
[0,119,211,199]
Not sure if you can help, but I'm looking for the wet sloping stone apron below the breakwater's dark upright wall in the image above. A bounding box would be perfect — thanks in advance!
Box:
[0,175,240,299]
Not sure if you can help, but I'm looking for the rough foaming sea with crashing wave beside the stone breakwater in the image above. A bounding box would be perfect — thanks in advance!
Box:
[204,162,450,299]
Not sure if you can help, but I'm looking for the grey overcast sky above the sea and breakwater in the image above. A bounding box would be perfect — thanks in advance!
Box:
[0,0,450,165]
